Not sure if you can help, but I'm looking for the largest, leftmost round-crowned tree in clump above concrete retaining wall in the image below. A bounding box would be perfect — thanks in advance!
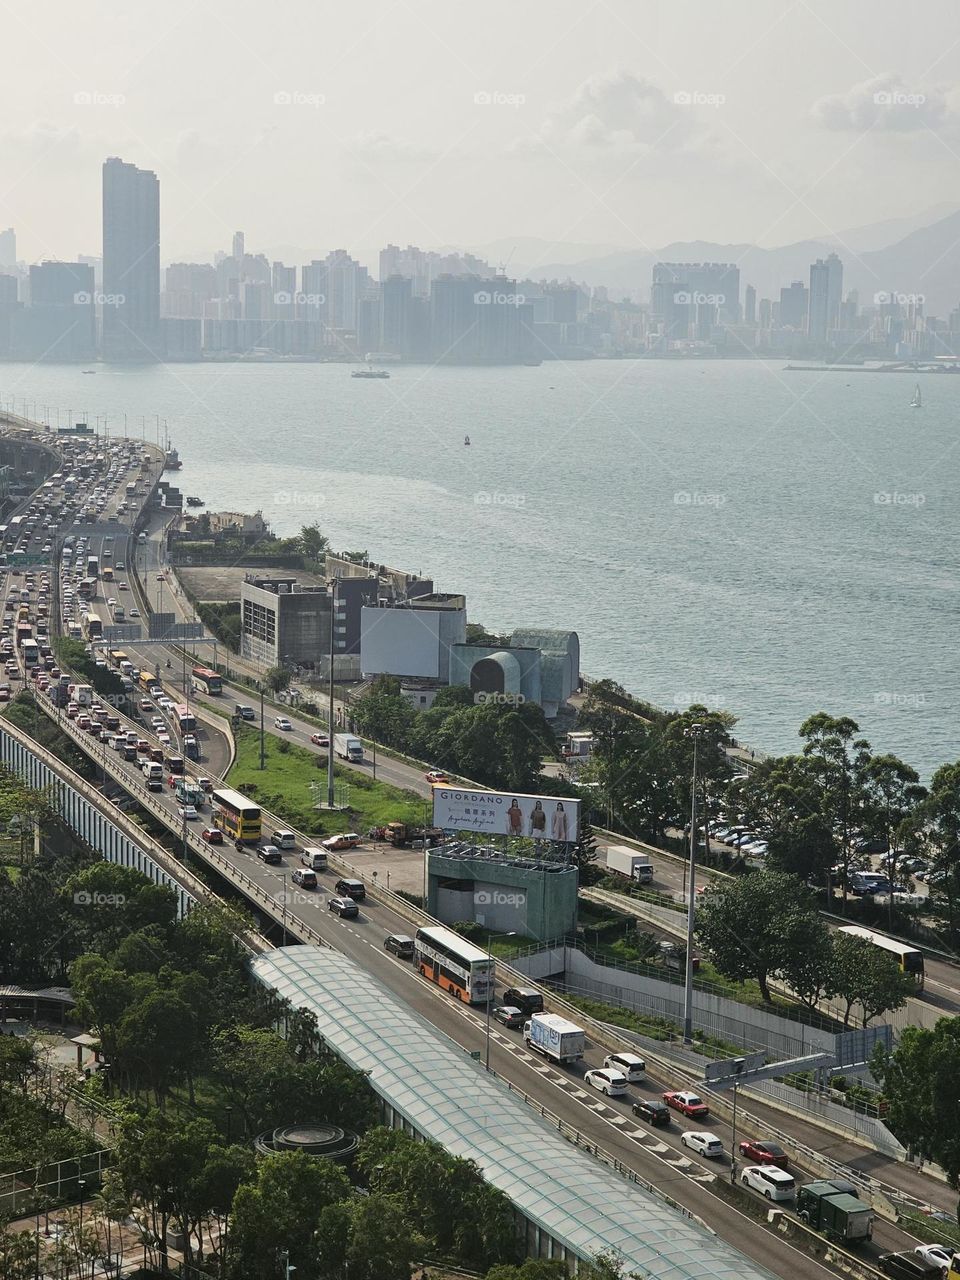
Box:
[696,870,819,1001]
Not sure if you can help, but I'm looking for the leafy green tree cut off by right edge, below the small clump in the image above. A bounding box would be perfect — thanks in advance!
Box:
[872,1018,960,1187]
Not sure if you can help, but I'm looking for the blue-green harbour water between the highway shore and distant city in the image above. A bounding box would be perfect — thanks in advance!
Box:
[0,361,960,776]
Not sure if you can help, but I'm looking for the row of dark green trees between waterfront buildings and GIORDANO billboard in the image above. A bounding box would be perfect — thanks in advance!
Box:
[353,676,557,791]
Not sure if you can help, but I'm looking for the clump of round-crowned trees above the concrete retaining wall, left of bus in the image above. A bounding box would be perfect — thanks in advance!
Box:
[696,870,916,1027]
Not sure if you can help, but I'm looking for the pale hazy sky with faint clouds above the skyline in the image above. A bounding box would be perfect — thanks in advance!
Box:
[0,0,960,270]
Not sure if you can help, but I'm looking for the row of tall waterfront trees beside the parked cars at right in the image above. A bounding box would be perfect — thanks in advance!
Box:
[580,681,960,937]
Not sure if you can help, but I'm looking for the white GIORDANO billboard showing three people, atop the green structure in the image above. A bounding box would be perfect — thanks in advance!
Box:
[434,786,580,844]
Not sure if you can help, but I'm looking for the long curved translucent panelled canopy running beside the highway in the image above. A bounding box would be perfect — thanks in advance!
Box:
[251,946,774,1280]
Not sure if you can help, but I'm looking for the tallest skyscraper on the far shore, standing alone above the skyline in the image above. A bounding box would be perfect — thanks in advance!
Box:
[101,156,163,360]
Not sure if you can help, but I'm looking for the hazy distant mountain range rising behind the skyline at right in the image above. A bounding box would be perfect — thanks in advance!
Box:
[522,206,960,317]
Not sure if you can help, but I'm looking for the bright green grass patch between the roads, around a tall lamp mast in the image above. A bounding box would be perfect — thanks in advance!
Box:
[228,727,424,836]
